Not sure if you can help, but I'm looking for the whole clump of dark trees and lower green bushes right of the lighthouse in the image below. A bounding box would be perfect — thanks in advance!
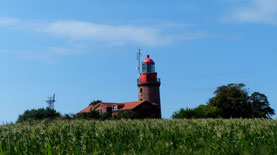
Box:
[172,83,275,118]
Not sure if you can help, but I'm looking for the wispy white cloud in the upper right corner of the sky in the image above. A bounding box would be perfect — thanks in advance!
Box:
[225,0,277,24]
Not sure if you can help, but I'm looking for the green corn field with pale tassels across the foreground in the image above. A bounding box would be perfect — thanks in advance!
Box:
[0,119,277,155]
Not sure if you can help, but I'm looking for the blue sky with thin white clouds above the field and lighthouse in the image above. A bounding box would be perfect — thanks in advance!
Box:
[0,0,277,122]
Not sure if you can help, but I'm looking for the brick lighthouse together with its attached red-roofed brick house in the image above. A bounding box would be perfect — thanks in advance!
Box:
[78,53,161,118]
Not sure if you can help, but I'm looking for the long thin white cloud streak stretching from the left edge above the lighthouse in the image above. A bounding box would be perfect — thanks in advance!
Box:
[0,17,208,46]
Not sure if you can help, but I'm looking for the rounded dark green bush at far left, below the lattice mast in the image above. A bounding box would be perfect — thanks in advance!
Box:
[17,108,61,122]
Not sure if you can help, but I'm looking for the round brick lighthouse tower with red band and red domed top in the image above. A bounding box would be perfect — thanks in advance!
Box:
[137,55,161,118]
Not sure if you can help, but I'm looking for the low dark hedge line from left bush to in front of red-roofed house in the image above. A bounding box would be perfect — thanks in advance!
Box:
[17,108,139,122]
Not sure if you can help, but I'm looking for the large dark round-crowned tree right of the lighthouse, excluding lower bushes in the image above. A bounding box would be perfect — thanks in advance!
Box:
[208,83,275,118]
